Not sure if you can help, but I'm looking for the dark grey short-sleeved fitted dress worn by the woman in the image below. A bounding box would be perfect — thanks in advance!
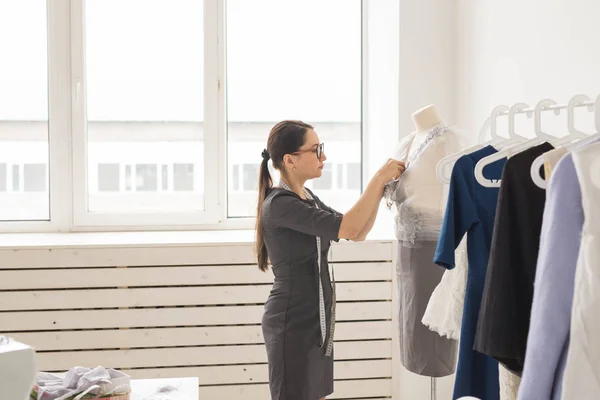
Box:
[262,188,342,400]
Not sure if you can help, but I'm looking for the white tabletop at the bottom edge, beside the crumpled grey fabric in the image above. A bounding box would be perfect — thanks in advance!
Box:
[130,377,199,400]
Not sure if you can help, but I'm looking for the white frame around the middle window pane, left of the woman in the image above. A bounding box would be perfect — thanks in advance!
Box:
[71,0,223,230]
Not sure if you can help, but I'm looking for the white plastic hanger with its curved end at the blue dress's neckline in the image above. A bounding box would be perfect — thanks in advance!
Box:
[475,99,560,188]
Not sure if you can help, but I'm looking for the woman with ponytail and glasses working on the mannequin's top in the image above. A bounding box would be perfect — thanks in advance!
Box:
[256,121,404,400]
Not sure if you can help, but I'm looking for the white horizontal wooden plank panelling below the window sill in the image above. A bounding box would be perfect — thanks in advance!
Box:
[0,242,394,400]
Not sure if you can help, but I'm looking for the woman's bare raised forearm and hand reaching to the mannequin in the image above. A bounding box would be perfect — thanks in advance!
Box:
[338,160,404,240]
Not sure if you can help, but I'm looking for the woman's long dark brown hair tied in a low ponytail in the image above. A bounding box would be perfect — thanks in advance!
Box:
[256,120,313,271]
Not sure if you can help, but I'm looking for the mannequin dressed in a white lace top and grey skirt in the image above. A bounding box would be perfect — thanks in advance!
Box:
[385,104,465,378]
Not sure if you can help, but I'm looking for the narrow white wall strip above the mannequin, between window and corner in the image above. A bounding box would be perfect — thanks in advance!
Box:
[399,0,456,137]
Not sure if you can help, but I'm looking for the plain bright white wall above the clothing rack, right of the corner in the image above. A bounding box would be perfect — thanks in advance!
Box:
[455,0,600,134]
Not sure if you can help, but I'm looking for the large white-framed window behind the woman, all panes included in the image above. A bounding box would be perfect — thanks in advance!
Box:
[0,0,400,232]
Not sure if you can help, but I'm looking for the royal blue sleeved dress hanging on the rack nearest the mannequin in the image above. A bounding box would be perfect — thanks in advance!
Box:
[434,146,506,400]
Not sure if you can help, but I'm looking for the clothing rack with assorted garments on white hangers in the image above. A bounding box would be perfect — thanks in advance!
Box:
[431,94,600,400]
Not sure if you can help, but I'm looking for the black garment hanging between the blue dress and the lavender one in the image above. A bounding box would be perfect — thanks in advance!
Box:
[474,142,553,375]
